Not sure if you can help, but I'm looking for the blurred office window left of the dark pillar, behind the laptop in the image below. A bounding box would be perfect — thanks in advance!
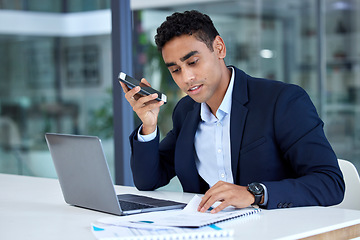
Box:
[0,0,114,177]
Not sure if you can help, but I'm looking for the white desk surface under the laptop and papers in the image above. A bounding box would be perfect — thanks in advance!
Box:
[0,174,360,240]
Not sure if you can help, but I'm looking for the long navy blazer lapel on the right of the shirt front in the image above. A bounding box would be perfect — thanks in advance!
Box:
[230,67,248,184]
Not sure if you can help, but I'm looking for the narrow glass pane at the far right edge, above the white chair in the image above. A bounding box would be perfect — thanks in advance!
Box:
[324,0,360,165]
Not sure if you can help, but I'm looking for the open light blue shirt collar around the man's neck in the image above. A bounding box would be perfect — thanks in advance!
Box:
[200,67,235,122]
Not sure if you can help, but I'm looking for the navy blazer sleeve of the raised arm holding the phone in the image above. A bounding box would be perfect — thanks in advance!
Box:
[130,97,194,190]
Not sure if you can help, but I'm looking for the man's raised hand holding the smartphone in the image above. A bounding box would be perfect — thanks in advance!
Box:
[119,78,164,135]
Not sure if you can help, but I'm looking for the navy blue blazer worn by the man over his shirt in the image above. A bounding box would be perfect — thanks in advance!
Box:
[130,68,345,209]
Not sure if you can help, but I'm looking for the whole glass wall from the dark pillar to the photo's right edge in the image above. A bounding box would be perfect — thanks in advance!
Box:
[133,0,360,170]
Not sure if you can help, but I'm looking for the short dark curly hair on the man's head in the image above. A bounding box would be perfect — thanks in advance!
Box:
[155,10,220,52]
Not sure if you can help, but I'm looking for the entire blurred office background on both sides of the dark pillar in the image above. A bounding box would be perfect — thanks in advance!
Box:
[0,0,360,186]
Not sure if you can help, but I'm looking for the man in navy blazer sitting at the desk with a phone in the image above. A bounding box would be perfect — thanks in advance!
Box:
[122,11,345,213]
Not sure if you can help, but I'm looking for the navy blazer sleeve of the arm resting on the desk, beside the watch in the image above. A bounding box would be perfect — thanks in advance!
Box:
[263,85,345,209]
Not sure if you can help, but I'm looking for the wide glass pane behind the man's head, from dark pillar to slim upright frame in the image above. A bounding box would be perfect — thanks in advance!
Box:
[134,0,318,134]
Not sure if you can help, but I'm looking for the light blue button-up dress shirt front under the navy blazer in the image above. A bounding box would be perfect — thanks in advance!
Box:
[195,68,235,187]
